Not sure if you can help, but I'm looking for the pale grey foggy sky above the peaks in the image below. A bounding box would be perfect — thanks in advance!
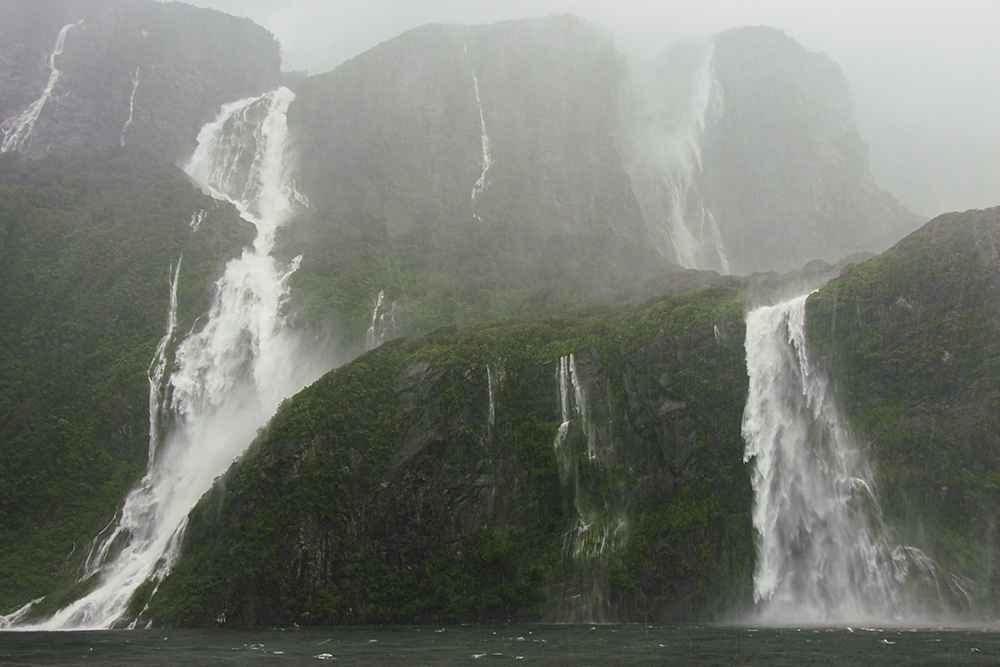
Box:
[176,0,1000,216]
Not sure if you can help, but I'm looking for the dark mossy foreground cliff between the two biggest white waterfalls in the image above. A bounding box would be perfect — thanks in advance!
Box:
[148,287,753,626]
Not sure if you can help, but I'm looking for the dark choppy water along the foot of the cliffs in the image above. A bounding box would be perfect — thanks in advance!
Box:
[0,625,1000,667]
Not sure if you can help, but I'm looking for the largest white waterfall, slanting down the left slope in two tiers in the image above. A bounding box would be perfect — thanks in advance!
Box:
[28,88,329,629]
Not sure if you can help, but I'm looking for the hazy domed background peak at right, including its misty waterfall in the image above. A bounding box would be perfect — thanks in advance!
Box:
[618,27,920,274]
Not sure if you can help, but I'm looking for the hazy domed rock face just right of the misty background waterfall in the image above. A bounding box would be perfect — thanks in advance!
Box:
[700,27,921,273]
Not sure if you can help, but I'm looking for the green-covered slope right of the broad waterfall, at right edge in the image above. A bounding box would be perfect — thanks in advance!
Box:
[808,208,1000,614]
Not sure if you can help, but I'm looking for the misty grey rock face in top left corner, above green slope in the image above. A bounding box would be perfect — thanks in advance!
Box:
[0,0,281,160]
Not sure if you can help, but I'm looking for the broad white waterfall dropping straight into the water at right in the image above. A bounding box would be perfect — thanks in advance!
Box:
[743,296,937,624]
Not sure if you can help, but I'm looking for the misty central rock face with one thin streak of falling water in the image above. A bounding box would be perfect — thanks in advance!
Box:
[289,16,644,248]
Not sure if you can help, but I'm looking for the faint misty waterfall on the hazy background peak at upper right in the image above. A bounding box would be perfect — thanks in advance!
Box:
[625,39,730,273]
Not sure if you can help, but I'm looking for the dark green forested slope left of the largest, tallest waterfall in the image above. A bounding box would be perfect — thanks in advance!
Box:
[0,151,251,613]
